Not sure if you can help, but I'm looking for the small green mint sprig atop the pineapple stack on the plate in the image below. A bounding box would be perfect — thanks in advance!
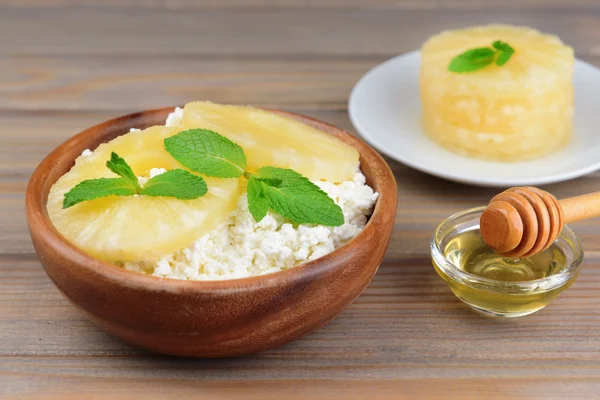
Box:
[448,40,515,73]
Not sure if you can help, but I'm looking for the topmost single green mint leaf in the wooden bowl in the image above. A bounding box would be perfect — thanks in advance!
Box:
[165,129,246,178]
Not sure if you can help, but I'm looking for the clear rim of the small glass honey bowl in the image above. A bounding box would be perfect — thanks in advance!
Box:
[430,206,584,294]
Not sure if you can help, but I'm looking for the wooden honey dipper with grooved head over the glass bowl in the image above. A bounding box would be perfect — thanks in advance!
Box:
[480,187,600,258]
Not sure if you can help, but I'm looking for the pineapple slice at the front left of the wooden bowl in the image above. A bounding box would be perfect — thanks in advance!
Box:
[47,126,245,262]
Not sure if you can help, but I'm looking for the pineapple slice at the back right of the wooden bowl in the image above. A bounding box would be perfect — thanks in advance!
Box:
[182,102,358,182]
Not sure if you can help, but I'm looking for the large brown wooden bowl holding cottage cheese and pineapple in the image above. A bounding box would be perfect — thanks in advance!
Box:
[26,108,397,357]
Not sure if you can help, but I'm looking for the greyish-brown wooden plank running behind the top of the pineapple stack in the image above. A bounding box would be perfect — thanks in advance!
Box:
[0,7,600,57]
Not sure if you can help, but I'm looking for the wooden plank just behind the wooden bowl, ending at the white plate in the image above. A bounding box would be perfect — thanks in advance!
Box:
[0,56,376,111]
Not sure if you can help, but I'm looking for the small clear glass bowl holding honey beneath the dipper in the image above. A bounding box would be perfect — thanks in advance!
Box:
[431,207,583,317]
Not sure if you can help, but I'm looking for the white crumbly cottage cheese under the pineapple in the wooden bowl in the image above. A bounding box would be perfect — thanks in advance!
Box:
[86,108,378,280]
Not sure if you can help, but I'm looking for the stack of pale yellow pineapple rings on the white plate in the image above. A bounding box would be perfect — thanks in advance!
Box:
[420,25,574,161]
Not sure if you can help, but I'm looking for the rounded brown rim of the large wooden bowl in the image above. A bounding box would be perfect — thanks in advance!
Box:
[25,106,397,292]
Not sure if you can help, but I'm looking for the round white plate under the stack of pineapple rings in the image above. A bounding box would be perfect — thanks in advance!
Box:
[348,52,600,187]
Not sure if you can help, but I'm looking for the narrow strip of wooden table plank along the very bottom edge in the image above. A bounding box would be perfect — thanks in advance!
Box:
[7,374,600,400]
